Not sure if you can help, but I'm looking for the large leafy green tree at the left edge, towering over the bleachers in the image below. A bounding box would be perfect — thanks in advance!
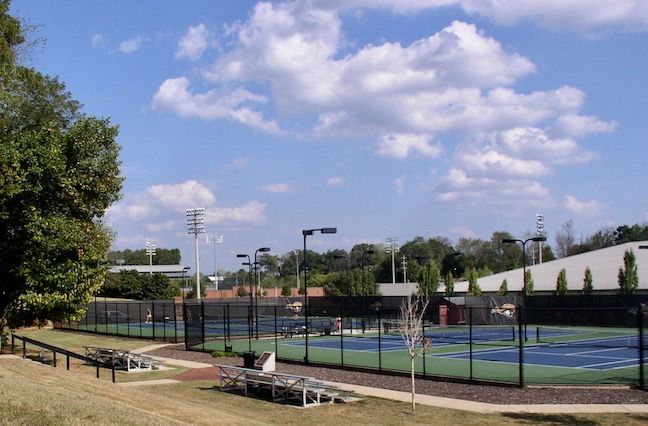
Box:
[0,0,122,328]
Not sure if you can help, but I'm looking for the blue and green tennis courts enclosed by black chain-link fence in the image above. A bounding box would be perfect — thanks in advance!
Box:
[52,296,648,386]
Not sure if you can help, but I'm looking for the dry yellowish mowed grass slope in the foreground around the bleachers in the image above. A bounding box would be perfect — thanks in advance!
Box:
[0,331,648,426]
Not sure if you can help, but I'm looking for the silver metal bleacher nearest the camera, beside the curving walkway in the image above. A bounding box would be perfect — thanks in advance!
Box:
[214,364,340,408]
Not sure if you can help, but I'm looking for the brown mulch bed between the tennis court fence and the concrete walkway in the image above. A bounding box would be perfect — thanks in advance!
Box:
[147,345,648,404]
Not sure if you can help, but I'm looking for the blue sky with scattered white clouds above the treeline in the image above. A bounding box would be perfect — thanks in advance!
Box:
[11,0,648,271]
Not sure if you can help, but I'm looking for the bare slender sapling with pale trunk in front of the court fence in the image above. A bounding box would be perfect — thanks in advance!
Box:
[398,294,430,414]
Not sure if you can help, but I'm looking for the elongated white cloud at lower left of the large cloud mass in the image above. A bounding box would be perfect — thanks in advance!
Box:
[153,77,280,134]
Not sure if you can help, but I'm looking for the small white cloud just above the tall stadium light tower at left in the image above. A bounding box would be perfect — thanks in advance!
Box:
[147,180,215,209]
